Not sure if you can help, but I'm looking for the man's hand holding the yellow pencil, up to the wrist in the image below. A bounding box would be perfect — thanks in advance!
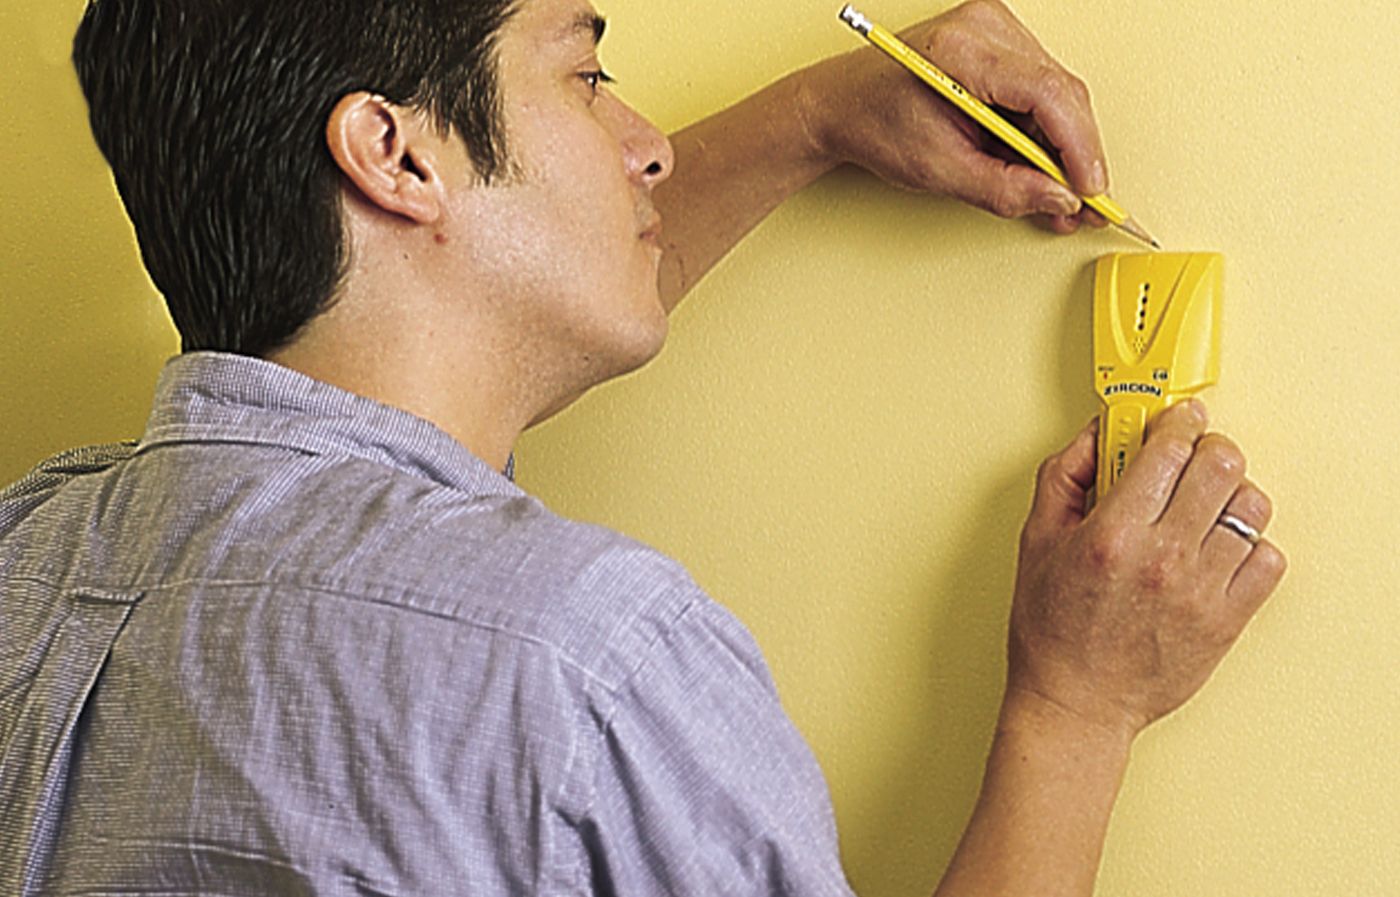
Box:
[804,0,1109,234]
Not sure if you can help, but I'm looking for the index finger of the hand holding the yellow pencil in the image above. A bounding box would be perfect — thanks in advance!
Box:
[986,57,1109,196]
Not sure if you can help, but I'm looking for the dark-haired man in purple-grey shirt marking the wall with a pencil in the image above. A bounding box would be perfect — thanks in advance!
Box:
[0,0,1284,897]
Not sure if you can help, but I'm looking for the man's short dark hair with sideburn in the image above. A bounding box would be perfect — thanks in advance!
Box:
[73,0,511,354]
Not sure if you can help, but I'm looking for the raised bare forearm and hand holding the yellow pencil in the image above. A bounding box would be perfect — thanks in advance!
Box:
[654,0,1107,312]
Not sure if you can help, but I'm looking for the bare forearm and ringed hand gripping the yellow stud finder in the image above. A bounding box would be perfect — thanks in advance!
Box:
[937,402,1287,897]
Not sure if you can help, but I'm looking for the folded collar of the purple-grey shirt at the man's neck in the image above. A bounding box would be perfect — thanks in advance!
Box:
[137,351,525,497]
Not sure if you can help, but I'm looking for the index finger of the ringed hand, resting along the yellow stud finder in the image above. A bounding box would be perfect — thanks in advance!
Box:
[1100,399,1210,523]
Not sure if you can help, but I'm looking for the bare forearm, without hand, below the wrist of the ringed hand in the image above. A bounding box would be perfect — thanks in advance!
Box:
[935,695,1131,897]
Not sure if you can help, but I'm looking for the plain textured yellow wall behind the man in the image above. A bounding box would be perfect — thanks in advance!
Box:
[0,0,1400,897]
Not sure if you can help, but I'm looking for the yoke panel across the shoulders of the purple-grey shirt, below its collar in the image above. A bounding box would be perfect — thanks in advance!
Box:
[0,444,713,687]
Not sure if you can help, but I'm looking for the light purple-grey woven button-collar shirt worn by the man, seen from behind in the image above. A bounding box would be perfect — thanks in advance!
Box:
[0,353,850,897]
